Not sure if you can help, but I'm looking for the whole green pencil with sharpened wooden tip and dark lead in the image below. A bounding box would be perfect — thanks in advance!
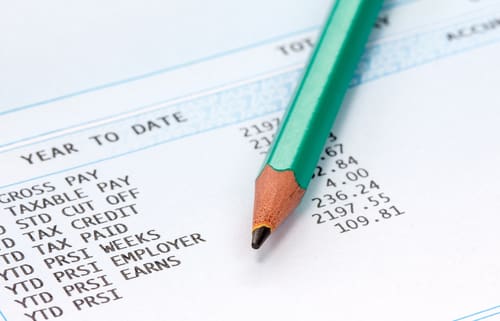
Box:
[252,0,383,249]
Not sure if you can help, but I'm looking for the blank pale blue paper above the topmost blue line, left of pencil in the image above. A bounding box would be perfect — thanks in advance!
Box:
[0,0,332,110]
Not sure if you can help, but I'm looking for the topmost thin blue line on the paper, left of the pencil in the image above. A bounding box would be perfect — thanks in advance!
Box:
[0,25,320,116]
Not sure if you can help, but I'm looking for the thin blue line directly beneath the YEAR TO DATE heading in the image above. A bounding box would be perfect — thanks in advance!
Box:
[0,108,282,190]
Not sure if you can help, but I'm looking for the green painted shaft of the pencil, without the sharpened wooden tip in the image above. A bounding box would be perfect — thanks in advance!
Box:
[265,0,383,189]
